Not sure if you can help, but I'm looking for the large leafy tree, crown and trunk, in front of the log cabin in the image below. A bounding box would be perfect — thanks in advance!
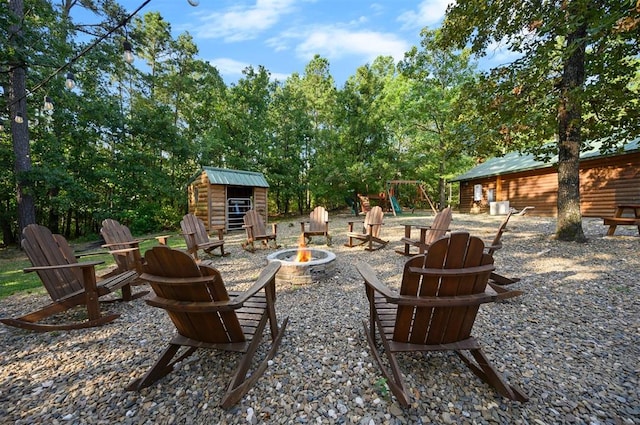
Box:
[443,0,640,241]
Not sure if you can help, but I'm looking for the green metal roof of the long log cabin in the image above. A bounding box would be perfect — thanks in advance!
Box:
[450,138,640,182]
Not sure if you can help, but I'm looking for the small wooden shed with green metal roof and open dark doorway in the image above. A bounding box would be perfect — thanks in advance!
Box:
[187,167,269,231]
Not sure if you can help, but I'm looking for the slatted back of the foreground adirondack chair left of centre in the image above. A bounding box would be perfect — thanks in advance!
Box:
[145,246,246,343]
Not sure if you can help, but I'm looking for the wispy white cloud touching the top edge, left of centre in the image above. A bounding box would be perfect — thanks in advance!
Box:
[191,0,296,42]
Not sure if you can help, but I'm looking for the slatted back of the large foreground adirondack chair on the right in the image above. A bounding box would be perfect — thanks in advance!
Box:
[393,233,493,345]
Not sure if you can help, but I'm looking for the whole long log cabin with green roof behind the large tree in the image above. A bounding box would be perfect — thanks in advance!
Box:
[451,139,640,217]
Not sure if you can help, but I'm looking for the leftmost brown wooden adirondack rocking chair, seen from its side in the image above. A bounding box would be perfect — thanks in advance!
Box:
[0,224,141,332]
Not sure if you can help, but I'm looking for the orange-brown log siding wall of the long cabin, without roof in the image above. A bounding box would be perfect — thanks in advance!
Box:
[460,152,640,217]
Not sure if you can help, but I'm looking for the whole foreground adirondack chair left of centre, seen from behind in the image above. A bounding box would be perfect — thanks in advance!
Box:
[127,246,288,409]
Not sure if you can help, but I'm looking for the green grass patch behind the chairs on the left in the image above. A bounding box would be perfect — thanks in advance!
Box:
[0,235,186,299]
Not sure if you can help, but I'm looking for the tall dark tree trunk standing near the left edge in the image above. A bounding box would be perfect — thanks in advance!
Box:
[8,0,36,239]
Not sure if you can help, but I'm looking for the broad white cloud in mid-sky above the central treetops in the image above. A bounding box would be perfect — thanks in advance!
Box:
[296,27,410,62]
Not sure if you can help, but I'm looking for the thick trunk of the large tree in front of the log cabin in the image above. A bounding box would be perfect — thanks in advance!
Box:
[556,24,586,242]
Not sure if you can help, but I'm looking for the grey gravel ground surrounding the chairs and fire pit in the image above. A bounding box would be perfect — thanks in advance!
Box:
[0,213,640,424]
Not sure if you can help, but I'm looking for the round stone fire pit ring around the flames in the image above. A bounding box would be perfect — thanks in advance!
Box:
[267,248,336,285]
